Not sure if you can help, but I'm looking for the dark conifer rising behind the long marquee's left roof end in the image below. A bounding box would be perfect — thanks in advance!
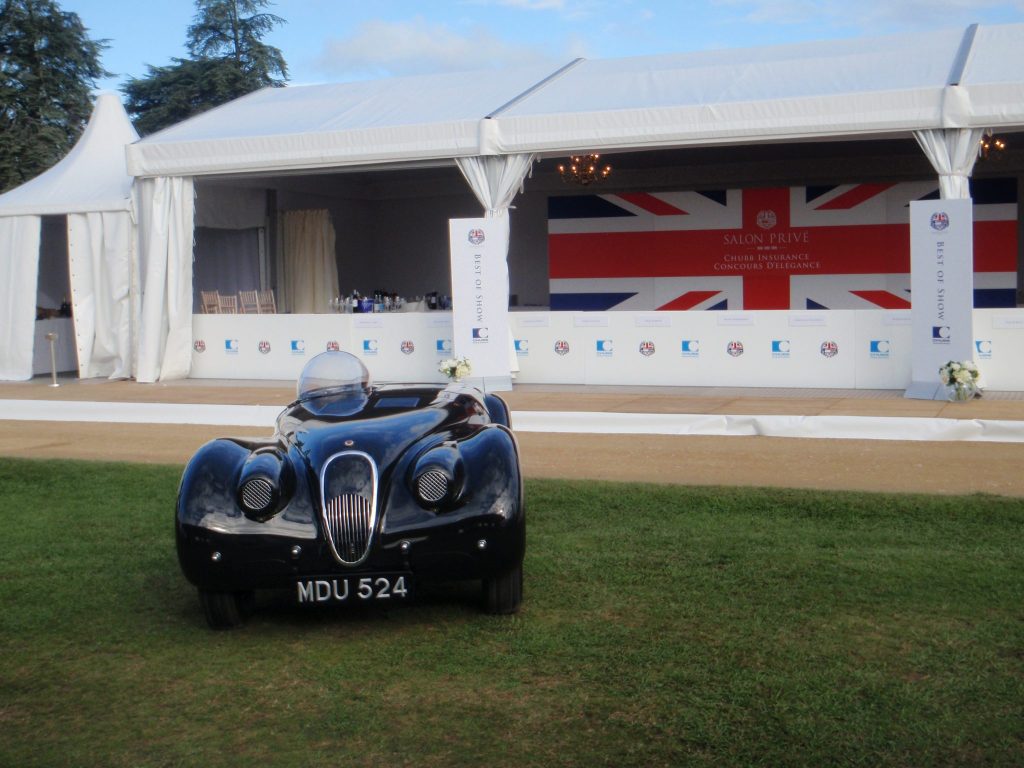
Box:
[122,0,288,135]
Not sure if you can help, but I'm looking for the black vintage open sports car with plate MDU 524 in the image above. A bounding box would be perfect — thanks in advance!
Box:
[176,352,526,629]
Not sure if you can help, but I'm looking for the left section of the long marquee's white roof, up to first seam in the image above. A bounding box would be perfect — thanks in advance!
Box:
[128,66,569,176]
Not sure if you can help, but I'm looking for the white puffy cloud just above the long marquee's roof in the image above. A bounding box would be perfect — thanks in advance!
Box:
[316,16,564,78]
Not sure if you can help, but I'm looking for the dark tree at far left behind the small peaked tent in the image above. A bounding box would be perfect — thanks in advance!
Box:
[0,0,110,191]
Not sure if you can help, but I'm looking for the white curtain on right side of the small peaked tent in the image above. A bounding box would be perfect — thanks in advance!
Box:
[68,211,135,379]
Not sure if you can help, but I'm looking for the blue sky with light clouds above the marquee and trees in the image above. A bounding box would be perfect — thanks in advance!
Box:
[68,0,1024,90]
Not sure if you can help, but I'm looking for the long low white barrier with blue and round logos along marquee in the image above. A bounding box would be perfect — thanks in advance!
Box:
[191,309,1024,391]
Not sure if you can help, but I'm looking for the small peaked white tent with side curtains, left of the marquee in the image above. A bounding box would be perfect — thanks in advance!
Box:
[0,93,138,380]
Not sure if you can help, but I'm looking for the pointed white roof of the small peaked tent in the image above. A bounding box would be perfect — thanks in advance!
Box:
[0,93,138,216]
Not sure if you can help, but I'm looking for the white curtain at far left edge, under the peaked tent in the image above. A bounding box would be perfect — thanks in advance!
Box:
[0,216,41,381]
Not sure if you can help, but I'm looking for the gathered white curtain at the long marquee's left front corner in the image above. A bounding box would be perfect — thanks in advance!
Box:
[135,177,195,382]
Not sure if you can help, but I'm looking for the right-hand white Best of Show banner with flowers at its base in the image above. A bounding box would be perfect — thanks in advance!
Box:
[905,200,974,400]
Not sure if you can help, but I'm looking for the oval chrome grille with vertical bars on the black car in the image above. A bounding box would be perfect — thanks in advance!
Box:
[321,451,377,565]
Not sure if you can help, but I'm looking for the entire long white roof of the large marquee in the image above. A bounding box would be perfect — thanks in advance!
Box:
[128,25,1024,176]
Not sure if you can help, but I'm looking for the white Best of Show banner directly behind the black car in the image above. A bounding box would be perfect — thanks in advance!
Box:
[449,212,511,390]
